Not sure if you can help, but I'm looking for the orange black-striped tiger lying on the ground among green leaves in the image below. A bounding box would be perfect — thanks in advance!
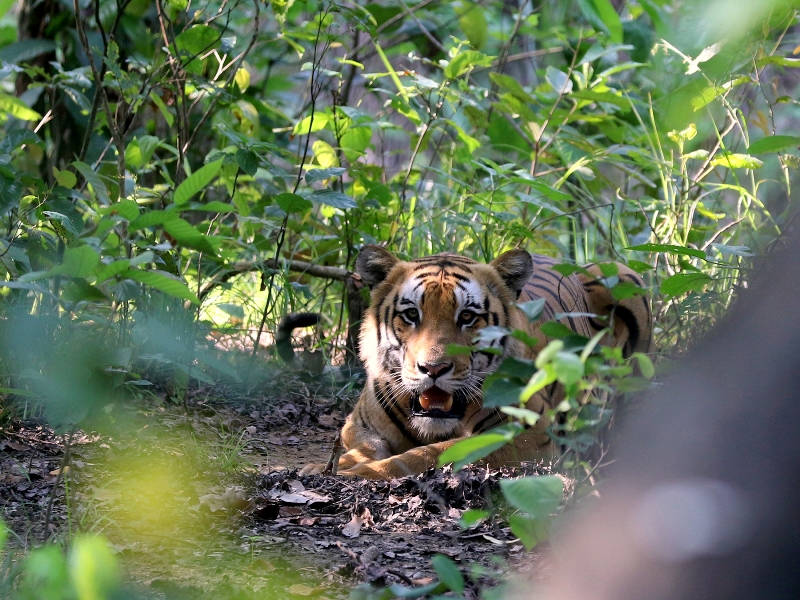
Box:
[301,245,653,479]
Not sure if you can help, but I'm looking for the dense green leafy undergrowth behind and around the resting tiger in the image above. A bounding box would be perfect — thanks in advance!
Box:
[0,0,800,597]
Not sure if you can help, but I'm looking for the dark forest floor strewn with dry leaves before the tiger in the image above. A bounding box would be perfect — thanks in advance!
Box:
[0,368,547,600]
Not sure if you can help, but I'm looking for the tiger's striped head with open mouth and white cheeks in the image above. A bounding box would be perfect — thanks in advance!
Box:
[356,245,533,439]
